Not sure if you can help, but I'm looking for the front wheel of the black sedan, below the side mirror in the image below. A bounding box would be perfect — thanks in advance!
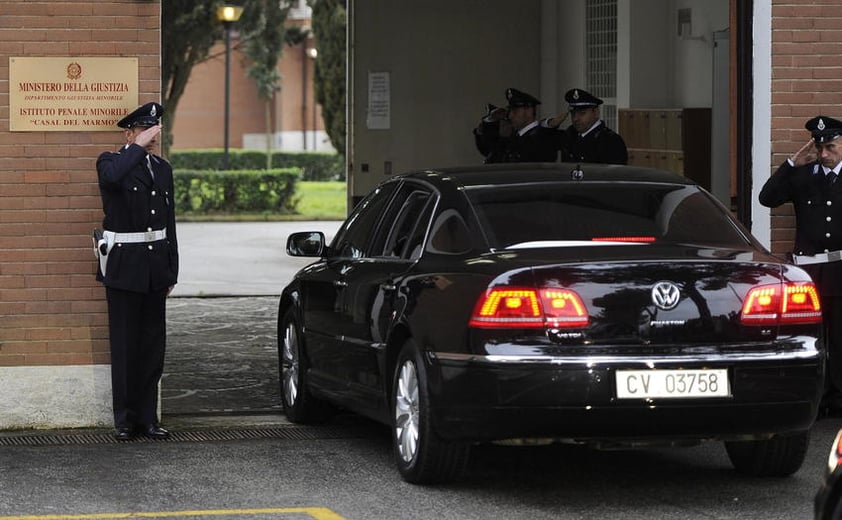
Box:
[278,309,330,424]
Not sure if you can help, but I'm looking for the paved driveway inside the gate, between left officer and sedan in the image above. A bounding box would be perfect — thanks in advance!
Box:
[161,222,341,422]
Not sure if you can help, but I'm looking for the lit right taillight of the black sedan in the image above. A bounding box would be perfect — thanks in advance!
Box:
[740,282,822,325]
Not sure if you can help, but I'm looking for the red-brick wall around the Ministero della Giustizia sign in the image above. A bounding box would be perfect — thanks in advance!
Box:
[0,0,161,372]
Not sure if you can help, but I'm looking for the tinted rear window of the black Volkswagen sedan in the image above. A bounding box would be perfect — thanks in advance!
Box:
[466,182,748,249]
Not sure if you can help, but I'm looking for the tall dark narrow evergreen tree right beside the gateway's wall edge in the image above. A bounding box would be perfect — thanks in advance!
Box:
[308,0,347,155]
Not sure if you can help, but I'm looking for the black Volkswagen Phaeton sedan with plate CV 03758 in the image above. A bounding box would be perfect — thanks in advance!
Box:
[278,163,824,483]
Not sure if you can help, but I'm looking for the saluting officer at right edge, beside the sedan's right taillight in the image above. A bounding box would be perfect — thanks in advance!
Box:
[759,116,842,415]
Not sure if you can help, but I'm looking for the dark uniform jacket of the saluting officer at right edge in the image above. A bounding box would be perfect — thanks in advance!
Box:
[759,161,842,296]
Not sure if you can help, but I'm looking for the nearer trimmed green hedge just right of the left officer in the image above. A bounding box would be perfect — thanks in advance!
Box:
[173,168,301,215]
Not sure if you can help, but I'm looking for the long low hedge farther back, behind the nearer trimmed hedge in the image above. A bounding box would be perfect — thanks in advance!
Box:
[168,148,345,181]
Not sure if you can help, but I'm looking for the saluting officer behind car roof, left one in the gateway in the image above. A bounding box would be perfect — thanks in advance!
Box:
[474,88,558,163]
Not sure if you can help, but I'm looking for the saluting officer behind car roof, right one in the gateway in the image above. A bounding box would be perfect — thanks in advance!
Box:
[542,88,629,164]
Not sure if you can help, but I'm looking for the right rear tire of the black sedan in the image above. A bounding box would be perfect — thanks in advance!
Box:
[725,431,810,477]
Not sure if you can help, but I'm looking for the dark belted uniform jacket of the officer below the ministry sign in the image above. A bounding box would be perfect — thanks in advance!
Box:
[97,144,178,293]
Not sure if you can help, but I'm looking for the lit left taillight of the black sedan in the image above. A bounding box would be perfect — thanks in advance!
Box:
[468,287,588,328]
